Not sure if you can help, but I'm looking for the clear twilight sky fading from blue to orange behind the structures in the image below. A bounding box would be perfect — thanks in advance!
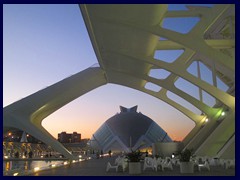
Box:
[3,4,226,140]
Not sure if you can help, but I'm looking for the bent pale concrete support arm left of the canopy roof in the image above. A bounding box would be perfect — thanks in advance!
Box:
[3,67,107,159]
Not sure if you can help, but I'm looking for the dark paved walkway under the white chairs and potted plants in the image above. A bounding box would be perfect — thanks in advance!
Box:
[32,157,235,176]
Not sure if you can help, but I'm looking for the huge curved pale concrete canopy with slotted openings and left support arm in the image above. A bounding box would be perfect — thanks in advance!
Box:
[4,4,235,158]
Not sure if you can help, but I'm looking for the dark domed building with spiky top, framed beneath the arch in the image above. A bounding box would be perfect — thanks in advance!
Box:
[89,106,172,152]
